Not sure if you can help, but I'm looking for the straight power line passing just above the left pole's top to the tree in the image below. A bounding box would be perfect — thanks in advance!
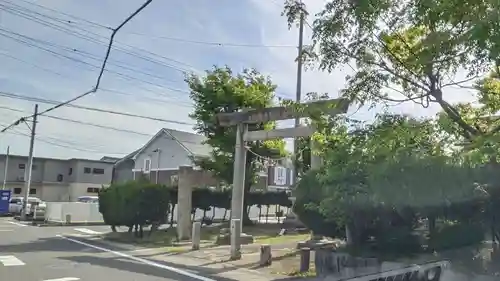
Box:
[0,91,194,125]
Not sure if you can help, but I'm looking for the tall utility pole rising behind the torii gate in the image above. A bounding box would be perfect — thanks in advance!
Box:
[292,1,304,184]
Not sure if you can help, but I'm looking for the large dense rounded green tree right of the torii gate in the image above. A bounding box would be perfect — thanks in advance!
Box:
[312,111,493,246]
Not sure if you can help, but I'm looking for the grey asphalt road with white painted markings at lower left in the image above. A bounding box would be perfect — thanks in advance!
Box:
[0,218,225,281]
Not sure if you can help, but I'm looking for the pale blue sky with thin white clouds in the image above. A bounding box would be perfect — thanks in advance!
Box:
[0,0,476,159]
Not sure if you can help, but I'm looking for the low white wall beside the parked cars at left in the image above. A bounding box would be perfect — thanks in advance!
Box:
[45,202,104,223]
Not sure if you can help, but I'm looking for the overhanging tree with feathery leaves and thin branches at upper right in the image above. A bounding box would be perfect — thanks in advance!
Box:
[283,0,500,141]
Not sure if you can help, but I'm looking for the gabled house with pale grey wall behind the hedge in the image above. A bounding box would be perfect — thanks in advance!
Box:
[113,128,292,190]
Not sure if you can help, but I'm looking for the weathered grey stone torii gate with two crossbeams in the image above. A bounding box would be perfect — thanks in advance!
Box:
[216,99,349,259]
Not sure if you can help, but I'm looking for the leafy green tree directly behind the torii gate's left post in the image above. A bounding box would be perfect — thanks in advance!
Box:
[186,67,285,224]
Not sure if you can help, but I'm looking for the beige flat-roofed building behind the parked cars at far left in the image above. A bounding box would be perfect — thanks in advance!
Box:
[0,154,113,202]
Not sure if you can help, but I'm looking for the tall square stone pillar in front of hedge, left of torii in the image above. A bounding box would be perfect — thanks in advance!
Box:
[177,166,193,240]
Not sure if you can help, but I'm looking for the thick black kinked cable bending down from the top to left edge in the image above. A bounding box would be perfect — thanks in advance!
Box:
[2,0,152,132]
